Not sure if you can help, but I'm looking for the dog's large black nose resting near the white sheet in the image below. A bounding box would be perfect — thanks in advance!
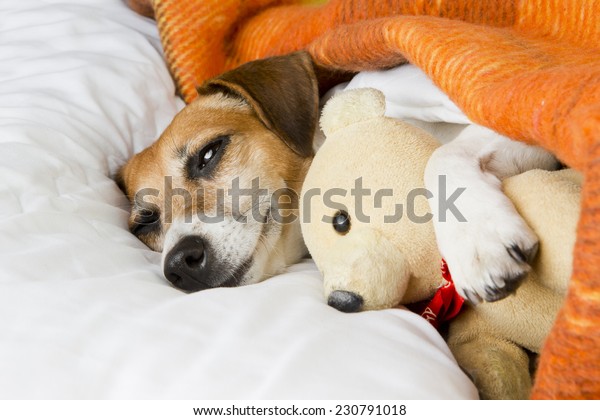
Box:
[163,236,212,292]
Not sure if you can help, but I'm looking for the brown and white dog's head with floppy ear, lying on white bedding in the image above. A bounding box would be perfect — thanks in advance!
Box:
[118,52,319,291]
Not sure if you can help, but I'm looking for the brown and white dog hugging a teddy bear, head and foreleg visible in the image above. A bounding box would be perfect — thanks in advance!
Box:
[117,52,557,303]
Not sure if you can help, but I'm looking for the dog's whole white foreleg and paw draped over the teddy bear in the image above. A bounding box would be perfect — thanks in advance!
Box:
[425,125,553,304]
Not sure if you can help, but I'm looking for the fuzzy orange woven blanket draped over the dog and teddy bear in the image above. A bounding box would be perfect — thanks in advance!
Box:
[130,0,600,399]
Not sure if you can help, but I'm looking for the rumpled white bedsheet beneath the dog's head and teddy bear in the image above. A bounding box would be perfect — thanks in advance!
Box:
[0,0,477,399]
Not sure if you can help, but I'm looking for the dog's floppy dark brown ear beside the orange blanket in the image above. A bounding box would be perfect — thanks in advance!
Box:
[198,51,319,157]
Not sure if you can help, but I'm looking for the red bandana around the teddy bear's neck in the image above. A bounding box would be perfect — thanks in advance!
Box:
[408,260,465,330]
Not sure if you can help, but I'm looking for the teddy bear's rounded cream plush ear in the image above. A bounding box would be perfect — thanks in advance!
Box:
[320,88,385,136]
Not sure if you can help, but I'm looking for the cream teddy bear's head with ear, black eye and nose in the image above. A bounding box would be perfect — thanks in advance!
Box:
[300,89,441,312]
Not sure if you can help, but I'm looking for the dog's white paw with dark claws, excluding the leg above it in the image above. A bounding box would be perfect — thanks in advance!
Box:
[436,202,539,304]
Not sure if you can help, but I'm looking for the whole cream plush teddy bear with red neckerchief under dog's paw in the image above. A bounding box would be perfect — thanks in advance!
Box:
[300,88,582,399]
